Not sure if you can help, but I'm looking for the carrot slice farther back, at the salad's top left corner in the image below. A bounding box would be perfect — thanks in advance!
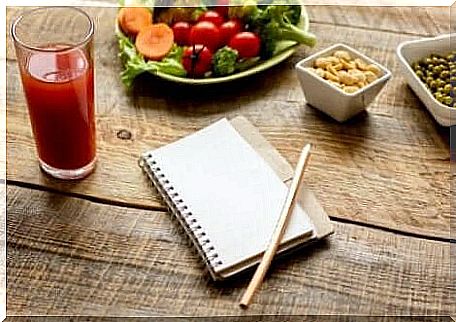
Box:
[117,7,152,37]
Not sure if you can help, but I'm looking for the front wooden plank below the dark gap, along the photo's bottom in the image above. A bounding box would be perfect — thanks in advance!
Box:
[7,186,456,316]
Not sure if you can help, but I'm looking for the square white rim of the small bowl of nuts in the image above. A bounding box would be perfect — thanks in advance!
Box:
[295,43,392,97]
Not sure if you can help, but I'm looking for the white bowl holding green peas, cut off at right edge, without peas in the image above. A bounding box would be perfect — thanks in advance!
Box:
[396,34,456,126]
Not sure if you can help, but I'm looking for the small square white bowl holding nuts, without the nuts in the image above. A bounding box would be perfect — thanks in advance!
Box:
[296,44,391,122]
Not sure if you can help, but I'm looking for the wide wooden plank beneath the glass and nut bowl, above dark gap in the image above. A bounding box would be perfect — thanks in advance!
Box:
[7,9,451,237]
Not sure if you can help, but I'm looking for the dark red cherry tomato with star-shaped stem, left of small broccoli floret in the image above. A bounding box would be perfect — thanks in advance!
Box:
[182,45,212,77]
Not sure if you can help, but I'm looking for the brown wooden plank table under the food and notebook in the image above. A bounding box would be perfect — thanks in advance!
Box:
[7,2,456,321]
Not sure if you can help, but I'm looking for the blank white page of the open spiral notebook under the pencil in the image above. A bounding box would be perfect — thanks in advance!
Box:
[153,119,312,271]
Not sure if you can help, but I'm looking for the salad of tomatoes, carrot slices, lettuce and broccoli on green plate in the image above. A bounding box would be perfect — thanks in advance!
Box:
[117,0,316,87]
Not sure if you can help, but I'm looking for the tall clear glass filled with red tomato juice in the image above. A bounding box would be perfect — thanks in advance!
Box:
[11,7,96,179]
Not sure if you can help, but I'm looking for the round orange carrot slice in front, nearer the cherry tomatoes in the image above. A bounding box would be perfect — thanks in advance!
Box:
[135,23,174,60]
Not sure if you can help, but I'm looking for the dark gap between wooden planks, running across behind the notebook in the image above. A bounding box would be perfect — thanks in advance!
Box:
[6,180,456,244]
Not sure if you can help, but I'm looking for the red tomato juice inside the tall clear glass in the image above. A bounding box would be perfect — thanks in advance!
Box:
[21,46,96,170]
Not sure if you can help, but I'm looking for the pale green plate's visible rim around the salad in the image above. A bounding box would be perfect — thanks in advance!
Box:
[116,5,309,85]
